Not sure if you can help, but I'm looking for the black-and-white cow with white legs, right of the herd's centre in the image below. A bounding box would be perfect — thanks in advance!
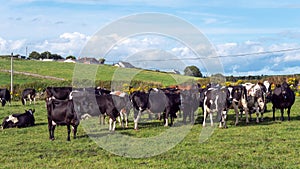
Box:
[203,87,231,128]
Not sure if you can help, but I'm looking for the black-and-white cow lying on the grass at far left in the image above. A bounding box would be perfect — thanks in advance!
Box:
[2,109,35,129]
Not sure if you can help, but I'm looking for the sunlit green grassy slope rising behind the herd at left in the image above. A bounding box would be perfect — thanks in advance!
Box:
[0,58,196,85]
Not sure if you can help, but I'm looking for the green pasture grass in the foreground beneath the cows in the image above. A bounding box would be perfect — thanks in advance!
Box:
[0,97,300,168]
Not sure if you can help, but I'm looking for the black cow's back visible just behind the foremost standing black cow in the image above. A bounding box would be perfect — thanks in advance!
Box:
[45,87,72,100]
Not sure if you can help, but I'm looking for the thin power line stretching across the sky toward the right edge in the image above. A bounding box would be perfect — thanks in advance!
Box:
[107,48,300,62]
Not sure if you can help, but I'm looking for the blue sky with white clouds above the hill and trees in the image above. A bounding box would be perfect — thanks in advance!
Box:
[0,0,300,76]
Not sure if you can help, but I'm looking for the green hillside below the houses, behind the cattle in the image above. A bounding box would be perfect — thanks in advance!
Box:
[0,58,199,86]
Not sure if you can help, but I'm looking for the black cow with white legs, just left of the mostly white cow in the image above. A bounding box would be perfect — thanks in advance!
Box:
[227,85,249,125]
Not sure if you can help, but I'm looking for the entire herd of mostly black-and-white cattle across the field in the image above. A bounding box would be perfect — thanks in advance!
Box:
[0,81,295,140]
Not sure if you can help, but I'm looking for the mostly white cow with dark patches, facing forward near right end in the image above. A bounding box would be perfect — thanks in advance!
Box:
[243,83,266,123]
